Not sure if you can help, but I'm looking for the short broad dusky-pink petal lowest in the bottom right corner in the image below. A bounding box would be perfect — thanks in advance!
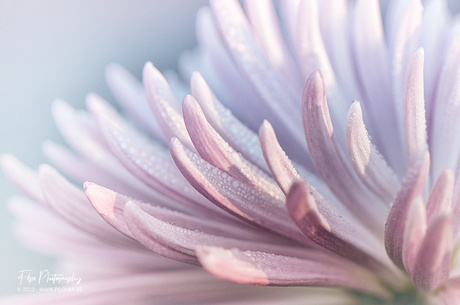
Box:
[412,214,453,290]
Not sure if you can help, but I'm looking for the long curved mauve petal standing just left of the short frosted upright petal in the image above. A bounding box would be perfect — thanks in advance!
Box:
[302,72,386,232]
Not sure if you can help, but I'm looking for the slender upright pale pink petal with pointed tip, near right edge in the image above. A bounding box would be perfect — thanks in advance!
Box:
[403,48,427,166]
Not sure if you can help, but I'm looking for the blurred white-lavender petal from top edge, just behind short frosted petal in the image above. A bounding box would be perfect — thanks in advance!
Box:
[351,0,404,174]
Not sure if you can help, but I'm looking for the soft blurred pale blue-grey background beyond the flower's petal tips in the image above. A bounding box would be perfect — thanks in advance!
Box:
[0,0,207,295]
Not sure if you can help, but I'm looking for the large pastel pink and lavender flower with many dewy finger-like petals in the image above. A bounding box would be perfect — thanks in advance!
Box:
[2,0,460,305]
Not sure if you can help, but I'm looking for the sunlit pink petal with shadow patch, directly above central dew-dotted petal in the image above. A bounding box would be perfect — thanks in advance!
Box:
[182,95,284,199]
